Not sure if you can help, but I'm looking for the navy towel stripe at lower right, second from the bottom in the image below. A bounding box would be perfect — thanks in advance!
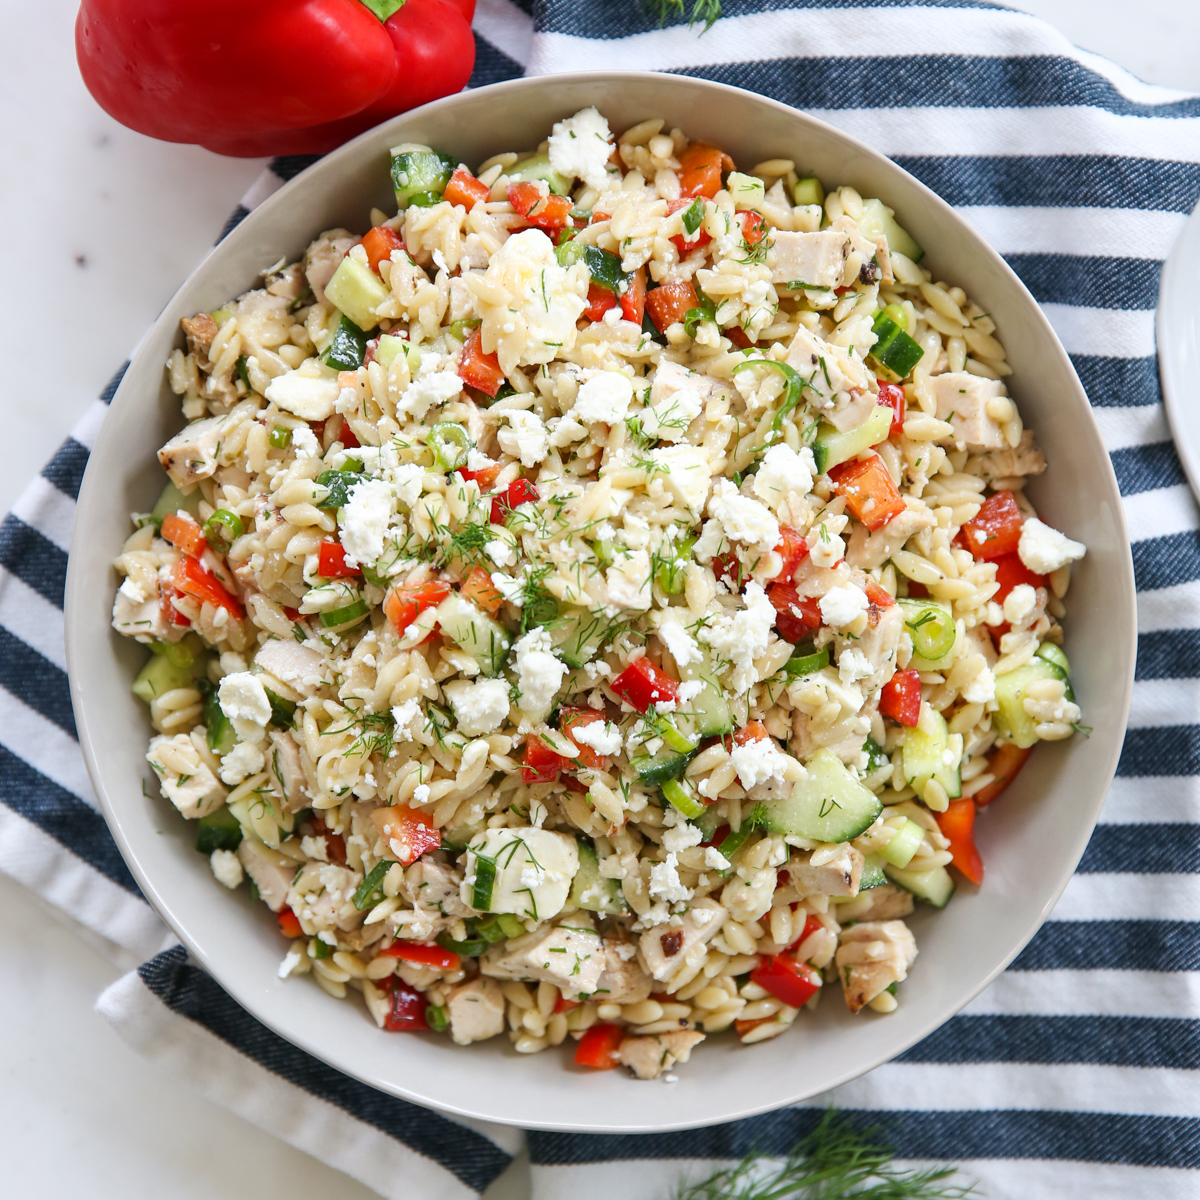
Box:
[896,1015,1200,1070]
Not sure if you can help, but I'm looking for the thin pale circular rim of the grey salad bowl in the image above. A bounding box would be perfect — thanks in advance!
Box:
[64,71,1136,1134]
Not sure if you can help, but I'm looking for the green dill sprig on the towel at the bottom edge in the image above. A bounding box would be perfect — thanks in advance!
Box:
[674,1109,979,1200]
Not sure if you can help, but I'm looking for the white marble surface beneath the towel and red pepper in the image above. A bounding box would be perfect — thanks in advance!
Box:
[0,0,1200,1200]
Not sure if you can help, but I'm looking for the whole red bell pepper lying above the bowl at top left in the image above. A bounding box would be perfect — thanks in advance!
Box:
[76,0,475,157]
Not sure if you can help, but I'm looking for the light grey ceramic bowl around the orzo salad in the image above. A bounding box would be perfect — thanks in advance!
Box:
[66,73,1135,1132]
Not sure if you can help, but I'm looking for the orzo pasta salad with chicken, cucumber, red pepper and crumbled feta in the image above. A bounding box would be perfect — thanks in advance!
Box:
[113,108,1084,1079]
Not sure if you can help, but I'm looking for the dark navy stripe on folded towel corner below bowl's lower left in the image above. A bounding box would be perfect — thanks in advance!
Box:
[138,946,510,1192]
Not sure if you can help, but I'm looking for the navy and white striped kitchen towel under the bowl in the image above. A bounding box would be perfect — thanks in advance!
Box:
[0,0,1200,1200]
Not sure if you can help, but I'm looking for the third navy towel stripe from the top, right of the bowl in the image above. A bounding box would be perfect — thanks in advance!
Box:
[894,154,1200,214]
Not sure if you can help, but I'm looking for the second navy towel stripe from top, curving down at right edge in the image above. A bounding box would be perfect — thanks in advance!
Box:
[674,54,1200,118]
